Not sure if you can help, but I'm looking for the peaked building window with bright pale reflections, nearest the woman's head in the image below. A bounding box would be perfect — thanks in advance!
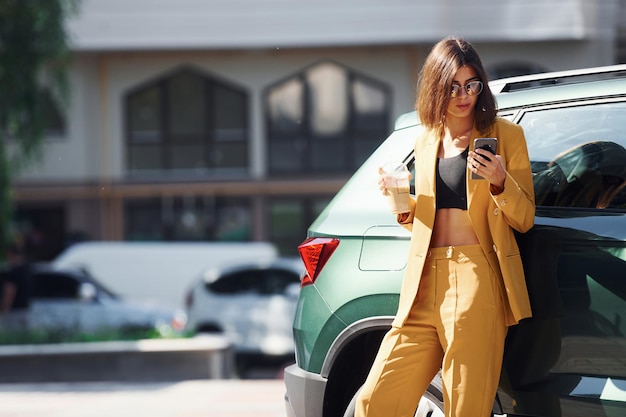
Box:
[264,62,391,174]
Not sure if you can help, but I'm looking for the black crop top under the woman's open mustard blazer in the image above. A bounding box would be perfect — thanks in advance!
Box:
[436,148,469,210]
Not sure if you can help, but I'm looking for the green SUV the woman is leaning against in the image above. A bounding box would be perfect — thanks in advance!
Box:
[284,65,626,417]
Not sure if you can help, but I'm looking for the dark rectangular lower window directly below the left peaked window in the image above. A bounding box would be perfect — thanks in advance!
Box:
[125,196,252,242]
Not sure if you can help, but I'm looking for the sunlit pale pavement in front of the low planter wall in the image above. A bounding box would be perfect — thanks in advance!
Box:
[0,379,286,417]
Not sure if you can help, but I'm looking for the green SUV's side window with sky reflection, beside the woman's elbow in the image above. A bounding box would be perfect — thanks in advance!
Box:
[519,102,626,210]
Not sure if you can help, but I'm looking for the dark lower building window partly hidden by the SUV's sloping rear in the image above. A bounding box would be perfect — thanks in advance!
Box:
[268,196,332,256]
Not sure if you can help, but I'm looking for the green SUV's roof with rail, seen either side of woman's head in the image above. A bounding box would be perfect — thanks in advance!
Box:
[395,64,626,130]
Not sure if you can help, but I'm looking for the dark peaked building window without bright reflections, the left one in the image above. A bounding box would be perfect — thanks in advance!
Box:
[125,69,249,178]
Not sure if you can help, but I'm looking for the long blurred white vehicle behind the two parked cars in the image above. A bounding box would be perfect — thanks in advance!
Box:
[51,241,278,309]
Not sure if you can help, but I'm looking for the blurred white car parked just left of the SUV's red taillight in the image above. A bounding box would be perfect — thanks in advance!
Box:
[186,258,304,356]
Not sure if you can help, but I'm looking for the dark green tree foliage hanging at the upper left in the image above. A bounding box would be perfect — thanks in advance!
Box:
[0,0,77,257]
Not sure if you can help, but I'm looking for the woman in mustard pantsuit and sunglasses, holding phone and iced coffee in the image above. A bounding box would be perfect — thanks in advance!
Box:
[356,37,535,417]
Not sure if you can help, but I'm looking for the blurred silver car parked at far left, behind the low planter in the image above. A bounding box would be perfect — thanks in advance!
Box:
[0,264,187,334]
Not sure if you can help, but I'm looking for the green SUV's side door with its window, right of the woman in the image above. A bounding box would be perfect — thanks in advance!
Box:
[500,98,626,416]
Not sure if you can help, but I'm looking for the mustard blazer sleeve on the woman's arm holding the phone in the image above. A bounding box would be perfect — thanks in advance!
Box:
[492,119,535,233]
